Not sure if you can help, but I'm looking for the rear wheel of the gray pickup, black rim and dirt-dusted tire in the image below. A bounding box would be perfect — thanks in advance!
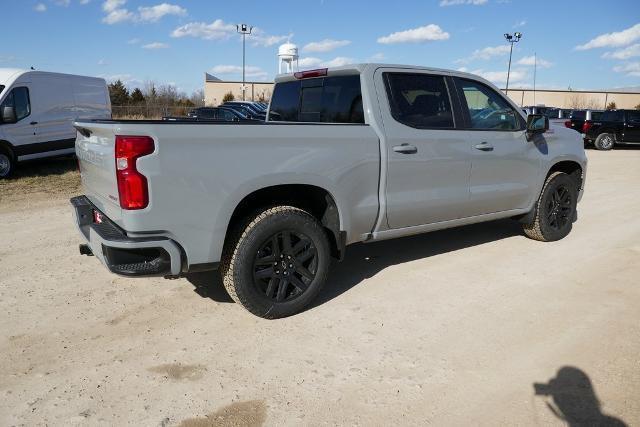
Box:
[220,206,331,319]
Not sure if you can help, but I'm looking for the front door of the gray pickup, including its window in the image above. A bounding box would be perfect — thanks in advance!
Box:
[456,78,545,215]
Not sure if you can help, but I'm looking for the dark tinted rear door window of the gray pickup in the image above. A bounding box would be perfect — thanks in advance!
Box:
[384,73,454,129]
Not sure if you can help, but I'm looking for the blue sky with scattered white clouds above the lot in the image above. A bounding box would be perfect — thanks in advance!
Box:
[0,0,640,93]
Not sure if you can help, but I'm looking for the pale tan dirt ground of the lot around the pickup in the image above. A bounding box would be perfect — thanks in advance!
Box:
[0,150,640,426]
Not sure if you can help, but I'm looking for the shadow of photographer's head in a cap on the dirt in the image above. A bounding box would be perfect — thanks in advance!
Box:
[533,366,626,427]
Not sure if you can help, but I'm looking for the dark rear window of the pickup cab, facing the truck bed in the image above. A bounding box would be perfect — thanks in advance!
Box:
[269,75,364,123]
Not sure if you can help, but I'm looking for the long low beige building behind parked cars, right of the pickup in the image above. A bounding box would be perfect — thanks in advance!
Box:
[508,89,640,110]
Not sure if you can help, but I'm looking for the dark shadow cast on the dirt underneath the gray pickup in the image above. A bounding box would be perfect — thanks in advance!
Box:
[187,219,525,309]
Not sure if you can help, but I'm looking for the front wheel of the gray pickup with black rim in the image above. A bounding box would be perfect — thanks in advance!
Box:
[522,172,578,242]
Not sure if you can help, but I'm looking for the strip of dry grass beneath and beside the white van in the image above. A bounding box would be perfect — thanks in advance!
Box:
[0,157,80,208]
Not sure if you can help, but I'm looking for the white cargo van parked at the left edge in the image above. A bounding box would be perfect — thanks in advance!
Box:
[0,68,111,179]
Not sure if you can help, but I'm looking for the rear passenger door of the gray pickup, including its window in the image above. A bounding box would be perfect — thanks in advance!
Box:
[374,69,471,229]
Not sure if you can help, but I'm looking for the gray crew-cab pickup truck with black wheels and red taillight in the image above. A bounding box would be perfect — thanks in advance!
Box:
[72,64,587,318]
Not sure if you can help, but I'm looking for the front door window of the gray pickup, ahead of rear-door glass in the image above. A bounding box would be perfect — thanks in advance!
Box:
[458,79,524,131]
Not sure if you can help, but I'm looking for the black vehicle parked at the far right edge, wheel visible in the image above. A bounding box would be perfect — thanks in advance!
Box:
[583,110,640,150]
